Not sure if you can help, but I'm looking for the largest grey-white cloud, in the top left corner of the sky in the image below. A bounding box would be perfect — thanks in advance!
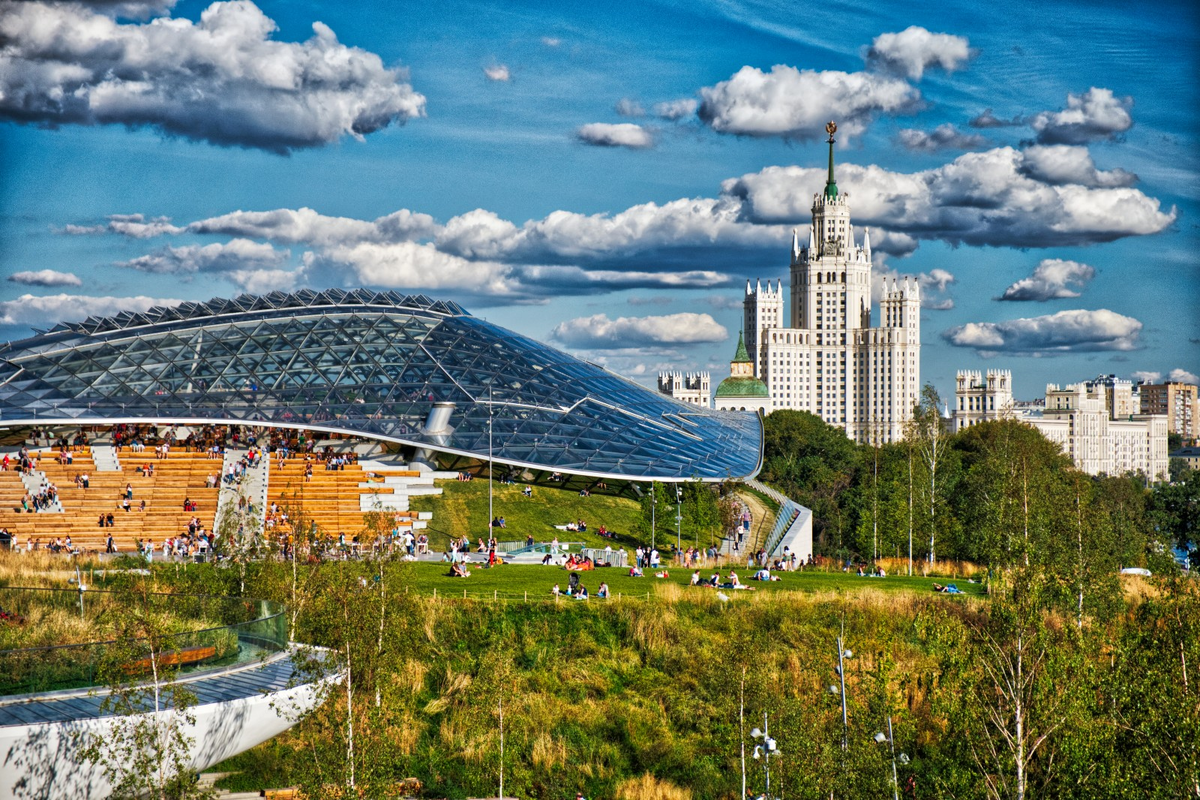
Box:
[0,0,425,154]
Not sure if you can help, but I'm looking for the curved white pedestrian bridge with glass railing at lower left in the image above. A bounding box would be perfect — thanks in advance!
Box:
[0,589,341,800]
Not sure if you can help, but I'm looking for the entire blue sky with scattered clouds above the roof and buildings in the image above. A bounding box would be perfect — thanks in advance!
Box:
[0,0,1200,398]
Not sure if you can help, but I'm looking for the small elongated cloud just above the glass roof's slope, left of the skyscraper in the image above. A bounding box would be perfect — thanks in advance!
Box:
[550,313,728,349]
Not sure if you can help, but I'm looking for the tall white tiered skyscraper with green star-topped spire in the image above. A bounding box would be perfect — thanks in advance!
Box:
[744,122,920,443]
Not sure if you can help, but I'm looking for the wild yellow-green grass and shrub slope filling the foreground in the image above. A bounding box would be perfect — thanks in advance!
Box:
[145,561,1200,799]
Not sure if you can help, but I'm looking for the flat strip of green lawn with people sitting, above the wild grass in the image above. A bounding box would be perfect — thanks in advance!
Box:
[412,563,984,601]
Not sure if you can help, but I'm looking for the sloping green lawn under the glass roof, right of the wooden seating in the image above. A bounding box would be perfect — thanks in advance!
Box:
[410,479,652,551]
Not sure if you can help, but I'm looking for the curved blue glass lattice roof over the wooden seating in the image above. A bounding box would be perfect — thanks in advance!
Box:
[0,290,762,481]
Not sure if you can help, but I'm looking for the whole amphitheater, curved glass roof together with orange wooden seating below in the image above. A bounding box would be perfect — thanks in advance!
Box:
[0,290,762,551]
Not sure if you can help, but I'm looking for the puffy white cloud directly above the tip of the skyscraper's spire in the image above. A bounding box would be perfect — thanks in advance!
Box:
[698,65,920,139]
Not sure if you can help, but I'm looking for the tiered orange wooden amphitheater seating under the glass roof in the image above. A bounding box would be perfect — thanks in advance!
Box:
[0,426,458,553]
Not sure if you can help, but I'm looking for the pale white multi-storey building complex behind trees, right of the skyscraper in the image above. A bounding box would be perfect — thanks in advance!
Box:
[952,369,1168,481]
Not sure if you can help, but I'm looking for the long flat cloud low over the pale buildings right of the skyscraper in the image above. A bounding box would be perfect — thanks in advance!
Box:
[942,308,1142,355]
